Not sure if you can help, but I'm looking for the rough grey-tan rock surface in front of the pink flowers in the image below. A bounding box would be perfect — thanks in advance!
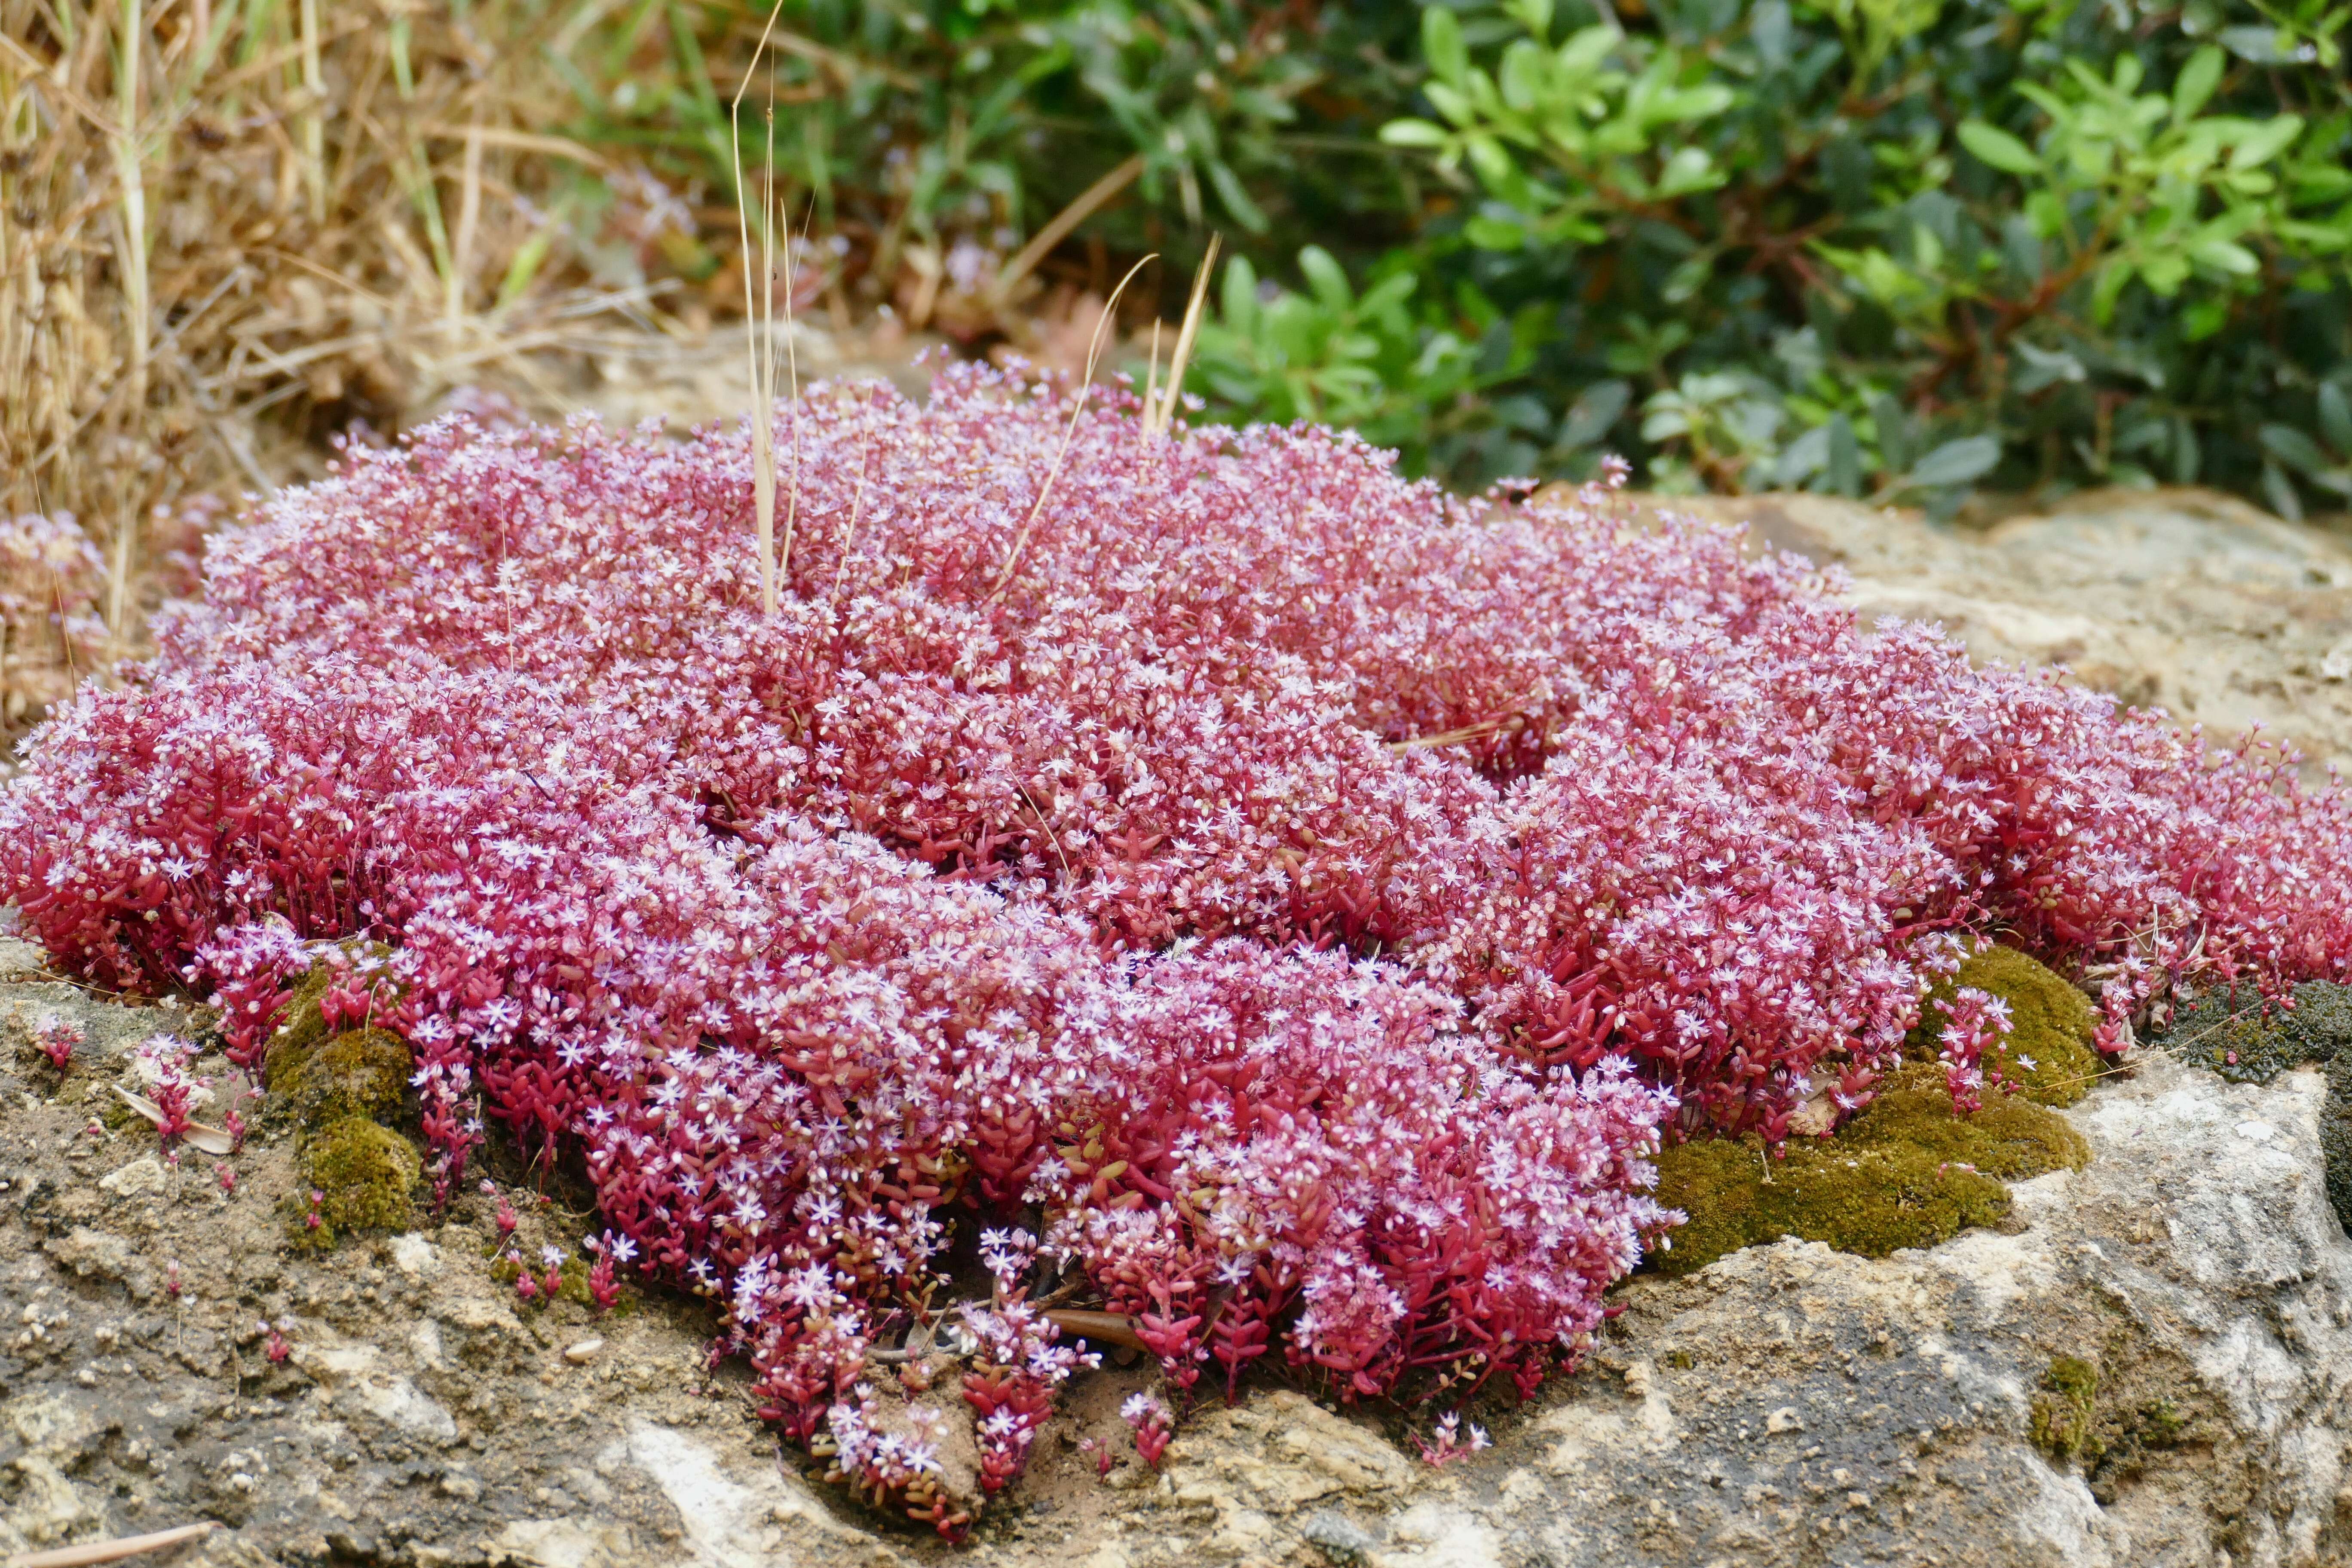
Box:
[0,926,2352,1568]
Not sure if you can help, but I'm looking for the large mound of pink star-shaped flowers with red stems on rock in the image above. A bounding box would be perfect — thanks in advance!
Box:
[0,369,2352,1528]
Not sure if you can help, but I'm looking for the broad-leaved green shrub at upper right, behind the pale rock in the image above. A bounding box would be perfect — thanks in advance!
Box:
[1211,0,2352,515]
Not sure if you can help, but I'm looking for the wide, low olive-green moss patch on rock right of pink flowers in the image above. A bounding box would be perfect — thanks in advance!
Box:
[1651,1065,2089,1277]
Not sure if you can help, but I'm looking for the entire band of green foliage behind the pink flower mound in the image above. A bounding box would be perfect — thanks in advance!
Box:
[572,0,2352,515]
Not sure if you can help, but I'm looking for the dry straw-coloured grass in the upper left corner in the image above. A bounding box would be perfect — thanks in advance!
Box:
[0,0,705,729]
